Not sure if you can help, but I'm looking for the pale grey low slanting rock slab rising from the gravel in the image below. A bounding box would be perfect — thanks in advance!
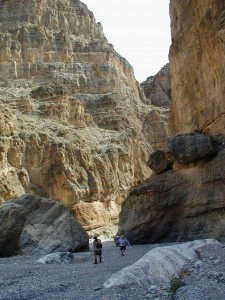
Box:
[104,240,221,288]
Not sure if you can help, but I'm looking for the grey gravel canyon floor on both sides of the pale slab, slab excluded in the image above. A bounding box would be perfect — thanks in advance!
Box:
[3,242,225,300]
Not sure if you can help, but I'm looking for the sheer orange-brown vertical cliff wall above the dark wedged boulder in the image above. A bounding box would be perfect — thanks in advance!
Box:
[170,0,225,135]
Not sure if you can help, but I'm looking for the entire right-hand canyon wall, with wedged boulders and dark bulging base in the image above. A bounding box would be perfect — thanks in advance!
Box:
[119,0,225,243]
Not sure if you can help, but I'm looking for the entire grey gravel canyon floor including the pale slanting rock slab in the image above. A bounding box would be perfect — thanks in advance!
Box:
[0,242,225,300]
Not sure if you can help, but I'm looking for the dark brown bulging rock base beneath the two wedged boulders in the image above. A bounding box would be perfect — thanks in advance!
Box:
[119,151,225,243]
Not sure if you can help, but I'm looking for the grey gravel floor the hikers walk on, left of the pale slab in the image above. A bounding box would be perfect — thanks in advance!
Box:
[0,242,171,300]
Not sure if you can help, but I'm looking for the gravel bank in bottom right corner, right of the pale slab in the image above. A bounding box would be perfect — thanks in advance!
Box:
[175,245,225,300]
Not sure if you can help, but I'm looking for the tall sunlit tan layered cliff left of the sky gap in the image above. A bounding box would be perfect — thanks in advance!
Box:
[0,0,171,236]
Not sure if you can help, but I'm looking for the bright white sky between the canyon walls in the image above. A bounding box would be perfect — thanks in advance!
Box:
[81,0,171,82]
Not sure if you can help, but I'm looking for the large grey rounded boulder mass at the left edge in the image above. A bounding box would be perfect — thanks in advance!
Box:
[0,194,89,256]
